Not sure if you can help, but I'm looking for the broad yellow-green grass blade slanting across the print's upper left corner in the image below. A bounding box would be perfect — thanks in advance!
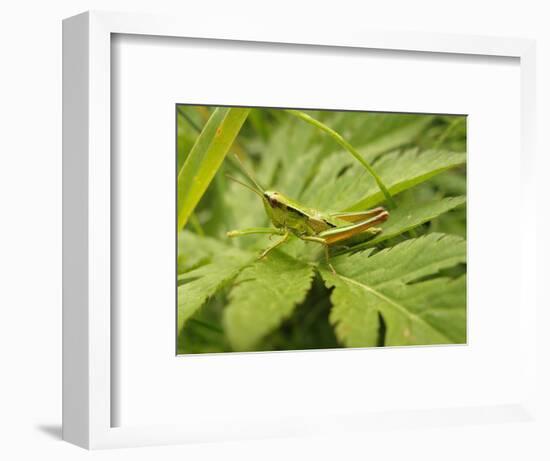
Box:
[178,107,250,231]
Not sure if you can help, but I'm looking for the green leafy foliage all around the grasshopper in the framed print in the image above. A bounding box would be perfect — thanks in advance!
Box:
[178,106,466,353]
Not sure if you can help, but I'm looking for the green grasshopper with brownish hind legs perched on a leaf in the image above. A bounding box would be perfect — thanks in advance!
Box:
[227,155,389,274]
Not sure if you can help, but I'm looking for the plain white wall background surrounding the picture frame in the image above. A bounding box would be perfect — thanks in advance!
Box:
[0,0,550,461]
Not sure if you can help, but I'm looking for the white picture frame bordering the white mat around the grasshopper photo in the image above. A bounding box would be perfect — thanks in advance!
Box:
[63,12,537,448]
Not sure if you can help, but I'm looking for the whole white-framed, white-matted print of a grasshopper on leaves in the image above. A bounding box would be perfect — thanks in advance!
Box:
[63,12,537,448]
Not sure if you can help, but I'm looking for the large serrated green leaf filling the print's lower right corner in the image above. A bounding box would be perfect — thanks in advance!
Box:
[322,234,466,347]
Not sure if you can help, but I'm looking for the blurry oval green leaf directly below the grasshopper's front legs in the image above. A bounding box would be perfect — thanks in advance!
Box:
[225,251,314,351]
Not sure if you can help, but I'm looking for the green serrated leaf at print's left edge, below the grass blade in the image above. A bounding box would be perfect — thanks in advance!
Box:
[178,236,255,332]
